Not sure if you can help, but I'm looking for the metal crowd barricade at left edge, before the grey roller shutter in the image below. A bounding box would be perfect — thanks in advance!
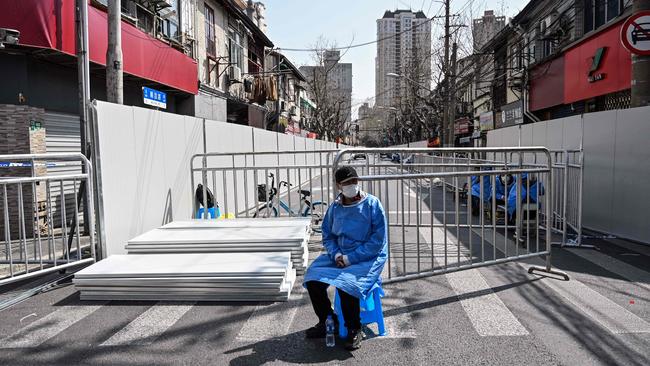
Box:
[0,154,96,286]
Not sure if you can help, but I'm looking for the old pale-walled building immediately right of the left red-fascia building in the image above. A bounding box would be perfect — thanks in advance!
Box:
[190,0,273,123]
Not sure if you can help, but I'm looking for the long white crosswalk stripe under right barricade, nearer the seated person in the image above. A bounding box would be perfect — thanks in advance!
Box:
[420,228,529,337]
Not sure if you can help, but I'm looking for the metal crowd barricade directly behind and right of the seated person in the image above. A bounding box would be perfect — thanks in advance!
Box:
[332,147,568,282]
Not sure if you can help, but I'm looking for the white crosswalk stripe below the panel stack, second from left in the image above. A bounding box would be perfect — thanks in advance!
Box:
[100,302,194,346]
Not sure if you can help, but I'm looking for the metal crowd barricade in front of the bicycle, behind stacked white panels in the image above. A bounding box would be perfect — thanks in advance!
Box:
[190,150,338,226]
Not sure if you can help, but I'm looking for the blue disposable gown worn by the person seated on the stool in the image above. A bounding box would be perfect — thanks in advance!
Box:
[303,194,388,299]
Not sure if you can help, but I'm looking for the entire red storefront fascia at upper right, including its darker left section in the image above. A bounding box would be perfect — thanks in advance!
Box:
[529,21,632,117]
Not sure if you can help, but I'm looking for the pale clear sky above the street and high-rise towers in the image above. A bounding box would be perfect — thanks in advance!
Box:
[262,0,528,115]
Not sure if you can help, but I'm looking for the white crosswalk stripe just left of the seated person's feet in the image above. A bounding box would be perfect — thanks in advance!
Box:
[236,280,306,342]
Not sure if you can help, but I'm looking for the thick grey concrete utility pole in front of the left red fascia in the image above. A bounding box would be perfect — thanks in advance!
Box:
[106,0,124,104]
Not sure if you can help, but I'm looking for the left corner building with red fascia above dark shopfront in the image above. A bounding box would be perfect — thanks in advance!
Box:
[0,0,198,164]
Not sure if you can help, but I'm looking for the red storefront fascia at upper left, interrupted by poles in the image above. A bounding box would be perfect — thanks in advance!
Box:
[0,0,198,94]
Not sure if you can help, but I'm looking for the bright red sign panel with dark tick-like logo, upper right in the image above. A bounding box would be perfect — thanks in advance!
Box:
[560,23,632,104]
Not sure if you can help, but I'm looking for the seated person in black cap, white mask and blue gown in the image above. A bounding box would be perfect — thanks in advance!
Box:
[304,166,388,350]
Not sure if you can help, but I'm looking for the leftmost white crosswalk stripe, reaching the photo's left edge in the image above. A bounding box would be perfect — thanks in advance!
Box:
[0,305,102,348]
